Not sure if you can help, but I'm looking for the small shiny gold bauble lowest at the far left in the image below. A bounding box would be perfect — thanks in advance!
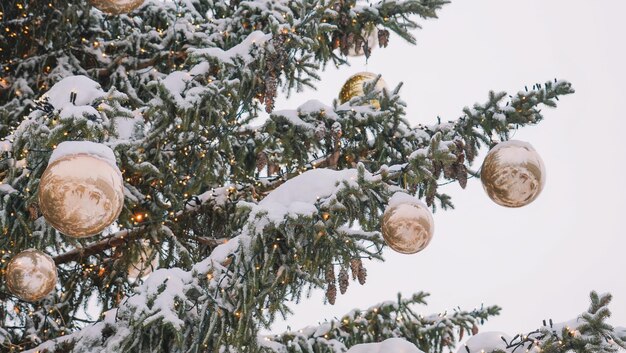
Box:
[5,249,57,302]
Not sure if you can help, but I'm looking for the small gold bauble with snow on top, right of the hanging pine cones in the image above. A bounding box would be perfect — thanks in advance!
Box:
[381,202,435,254]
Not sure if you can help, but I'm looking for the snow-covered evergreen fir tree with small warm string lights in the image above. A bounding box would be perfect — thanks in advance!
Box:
[0,0,626,353]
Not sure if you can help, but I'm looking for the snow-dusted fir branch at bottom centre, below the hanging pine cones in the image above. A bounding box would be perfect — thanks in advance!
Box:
[259,292,500,353]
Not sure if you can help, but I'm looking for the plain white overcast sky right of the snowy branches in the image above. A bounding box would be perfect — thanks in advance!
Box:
[266,0,626,340]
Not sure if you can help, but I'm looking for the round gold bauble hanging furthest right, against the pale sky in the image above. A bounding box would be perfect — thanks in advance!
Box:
[480,140,546,207]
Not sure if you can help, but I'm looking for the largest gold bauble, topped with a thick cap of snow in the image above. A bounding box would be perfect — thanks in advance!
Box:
[39,153,124,238]
